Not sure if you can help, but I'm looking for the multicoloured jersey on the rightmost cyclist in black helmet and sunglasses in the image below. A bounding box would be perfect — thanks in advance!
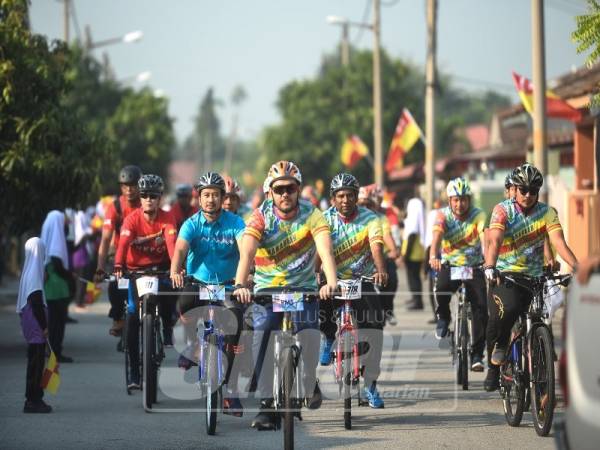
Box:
[490,200,562,277]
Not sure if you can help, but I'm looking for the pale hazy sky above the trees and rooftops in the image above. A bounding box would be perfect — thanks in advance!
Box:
[30,0,586,141]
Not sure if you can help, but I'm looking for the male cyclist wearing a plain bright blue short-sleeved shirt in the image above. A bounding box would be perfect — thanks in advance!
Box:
[171,172,245,417]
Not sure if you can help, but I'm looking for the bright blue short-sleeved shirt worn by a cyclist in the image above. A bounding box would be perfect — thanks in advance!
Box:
[178,210,245,283]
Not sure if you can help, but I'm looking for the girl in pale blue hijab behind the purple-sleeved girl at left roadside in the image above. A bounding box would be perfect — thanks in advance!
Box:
[41,210,74,363]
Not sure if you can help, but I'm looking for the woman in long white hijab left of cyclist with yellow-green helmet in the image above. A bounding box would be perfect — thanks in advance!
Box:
[402,198,425,310]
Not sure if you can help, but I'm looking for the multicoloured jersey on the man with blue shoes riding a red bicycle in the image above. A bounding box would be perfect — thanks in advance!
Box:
[323,206,383,280]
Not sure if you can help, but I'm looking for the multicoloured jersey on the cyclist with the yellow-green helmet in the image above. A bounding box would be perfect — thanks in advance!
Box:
[432,206,486,267]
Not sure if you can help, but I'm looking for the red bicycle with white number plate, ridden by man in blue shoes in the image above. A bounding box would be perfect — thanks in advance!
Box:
[333,277,373,430]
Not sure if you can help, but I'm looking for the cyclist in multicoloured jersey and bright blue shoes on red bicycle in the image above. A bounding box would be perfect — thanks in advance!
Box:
[320,173,388,408]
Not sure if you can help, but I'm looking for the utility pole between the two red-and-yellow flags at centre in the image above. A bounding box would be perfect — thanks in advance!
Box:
[373,0,383,187]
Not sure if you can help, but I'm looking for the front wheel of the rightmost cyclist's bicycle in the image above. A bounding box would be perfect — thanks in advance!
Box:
[531,326,556,436]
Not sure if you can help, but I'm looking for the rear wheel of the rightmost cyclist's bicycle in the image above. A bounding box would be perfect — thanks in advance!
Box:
[500,341,526,427]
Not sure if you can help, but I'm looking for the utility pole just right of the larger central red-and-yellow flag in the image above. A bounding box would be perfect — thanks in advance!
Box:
[425,0,437,210]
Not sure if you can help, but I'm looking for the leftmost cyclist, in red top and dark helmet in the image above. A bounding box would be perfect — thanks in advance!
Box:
[94,166,142,336]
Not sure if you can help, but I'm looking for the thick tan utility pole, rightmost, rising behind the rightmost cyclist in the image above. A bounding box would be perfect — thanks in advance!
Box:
[531,0,548,202]
